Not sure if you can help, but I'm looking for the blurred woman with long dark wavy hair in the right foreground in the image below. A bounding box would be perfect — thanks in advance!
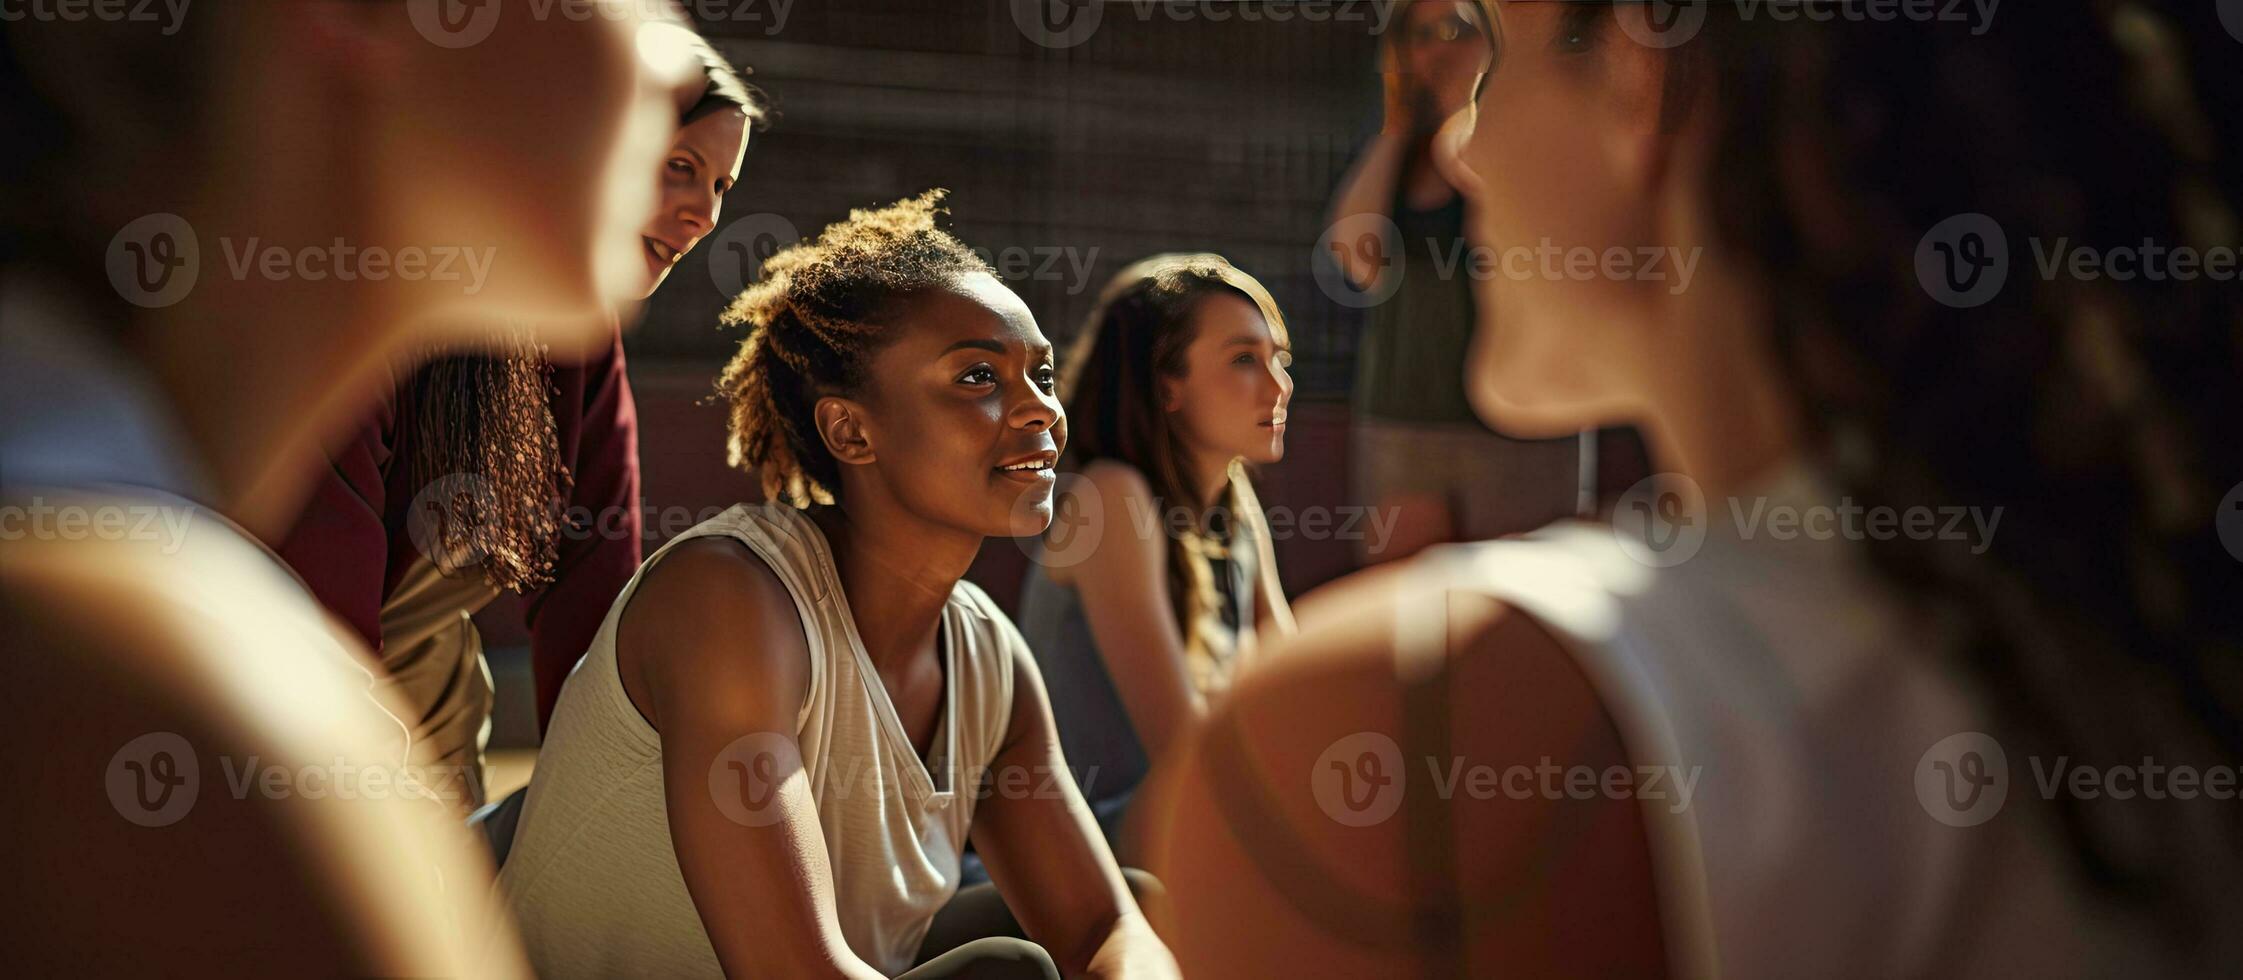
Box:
[1151,2,2243,978]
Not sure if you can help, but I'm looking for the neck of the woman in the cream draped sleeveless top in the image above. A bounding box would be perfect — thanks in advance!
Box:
[812,500,982,666]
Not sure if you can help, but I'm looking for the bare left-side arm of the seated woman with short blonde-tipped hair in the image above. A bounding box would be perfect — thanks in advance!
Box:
[617,538,879,978]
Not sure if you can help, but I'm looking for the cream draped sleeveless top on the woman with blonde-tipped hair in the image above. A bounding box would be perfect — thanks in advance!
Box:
[500,505,1023,978]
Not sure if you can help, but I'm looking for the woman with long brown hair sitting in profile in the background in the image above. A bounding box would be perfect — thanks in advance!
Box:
[1021,253,1292,863]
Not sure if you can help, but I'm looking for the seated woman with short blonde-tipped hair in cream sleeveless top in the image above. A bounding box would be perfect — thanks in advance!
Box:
[502,191,1173,978]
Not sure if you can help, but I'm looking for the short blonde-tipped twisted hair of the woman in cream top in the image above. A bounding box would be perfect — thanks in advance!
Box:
[716,188,989,509]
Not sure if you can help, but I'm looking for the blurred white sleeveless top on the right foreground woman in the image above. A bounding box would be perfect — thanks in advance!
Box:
[1395,461,2160,978]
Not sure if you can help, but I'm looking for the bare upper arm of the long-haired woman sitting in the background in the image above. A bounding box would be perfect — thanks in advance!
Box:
[1074,462,1207,760]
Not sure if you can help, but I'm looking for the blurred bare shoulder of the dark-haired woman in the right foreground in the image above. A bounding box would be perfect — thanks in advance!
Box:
[1153,565,1660,976]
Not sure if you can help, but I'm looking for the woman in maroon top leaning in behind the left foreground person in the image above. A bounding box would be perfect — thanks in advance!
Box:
[276,38,765,812]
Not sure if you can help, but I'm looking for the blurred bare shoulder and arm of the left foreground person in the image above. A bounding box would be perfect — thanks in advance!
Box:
[0,542,529,978]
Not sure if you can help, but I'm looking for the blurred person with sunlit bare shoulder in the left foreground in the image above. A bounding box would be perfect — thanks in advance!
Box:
[0,0,698,976]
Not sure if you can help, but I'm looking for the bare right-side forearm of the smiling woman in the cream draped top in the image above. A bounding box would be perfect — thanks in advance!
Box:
[973,641,1178,978]
